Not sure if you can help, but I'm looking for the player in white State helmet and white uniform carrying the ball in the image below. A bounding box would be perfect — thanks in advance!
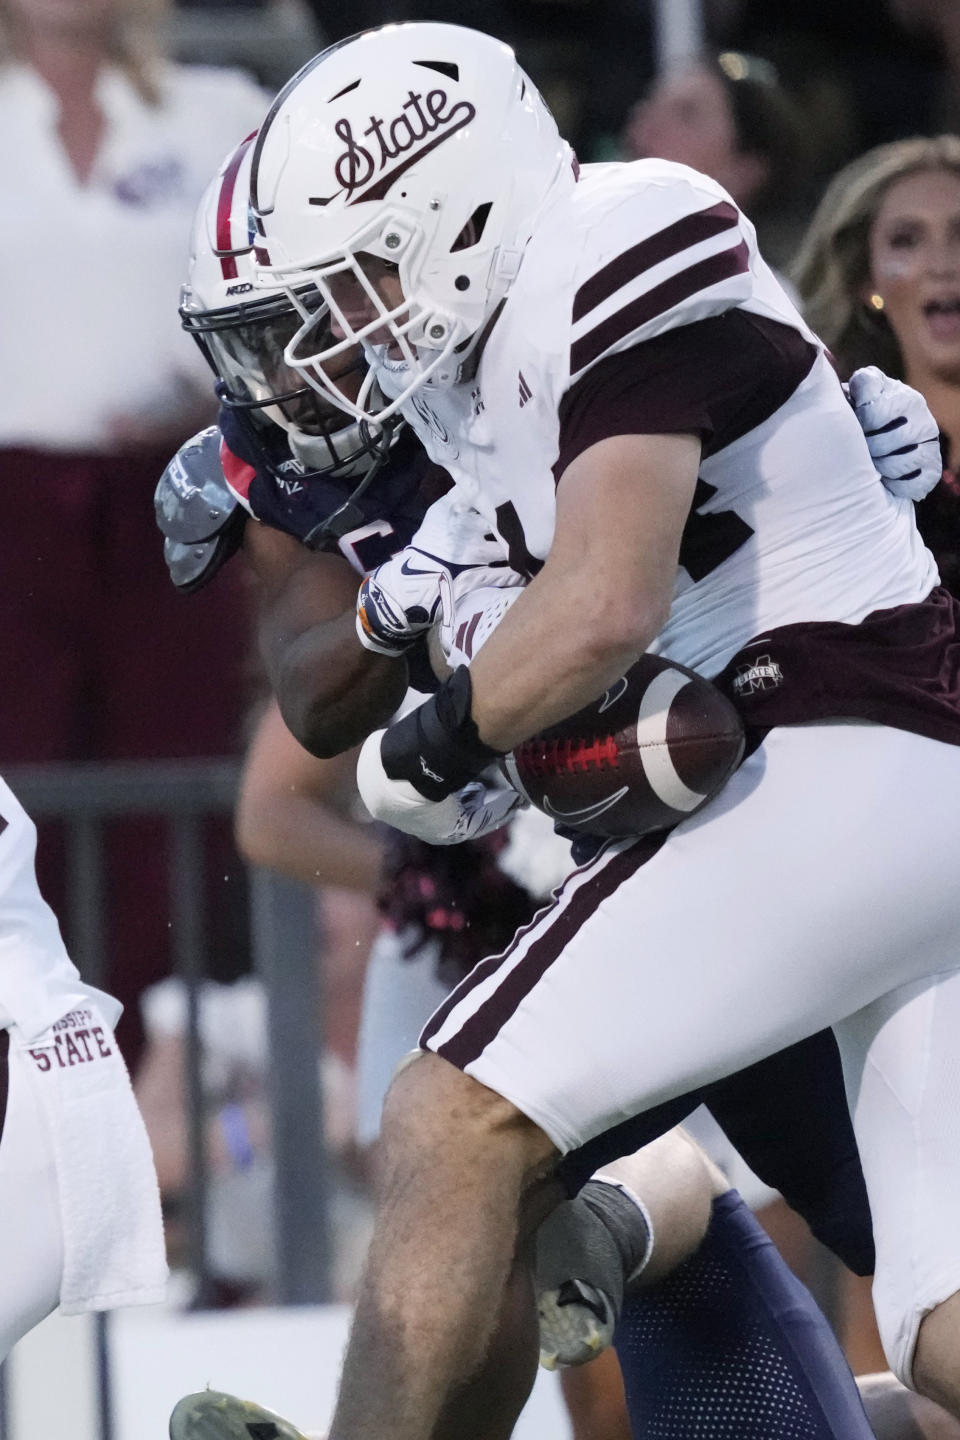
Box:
[233,24,960,1440]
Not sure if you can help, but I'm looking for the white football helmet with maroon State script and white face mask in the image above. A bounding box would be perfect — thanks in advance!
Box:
[250,23,577,419]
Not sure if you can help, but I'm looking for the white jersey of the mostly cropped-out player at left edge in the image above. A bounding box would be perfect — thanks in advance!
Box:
[0,780,121,1040]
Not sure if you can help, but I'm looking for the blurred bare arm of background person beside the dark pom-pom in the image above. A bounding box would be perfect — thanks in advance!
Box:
[233,701,384,894]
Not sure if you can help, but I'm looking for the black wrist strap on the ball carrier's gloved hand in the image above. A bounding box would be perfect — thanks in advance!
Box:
[380,665,501,801]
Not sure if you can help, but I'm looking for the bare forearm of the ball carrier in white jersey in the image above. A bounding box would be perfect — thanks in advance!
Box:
[471,435,699,750]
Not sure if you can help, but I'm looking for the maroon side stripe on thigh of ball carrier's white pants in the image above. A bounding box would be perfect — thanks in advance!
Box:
[423,834,666,1070]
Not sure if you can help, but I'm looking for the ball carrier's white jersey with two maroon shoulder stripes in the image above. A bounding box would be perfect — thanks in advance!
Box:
[381,160,937,675]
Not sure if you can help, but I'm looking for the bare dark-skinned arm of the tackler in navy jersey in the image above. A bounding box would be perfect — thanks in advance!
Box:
[243,523,406,759]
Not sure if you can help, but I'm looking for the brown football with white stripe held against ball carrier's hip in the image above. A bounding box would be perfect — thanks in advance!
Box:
[504,655,744,837]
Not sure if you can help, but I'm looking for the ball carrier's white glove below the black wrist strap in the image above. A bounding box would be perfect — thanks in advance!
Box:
[357,730,524,845]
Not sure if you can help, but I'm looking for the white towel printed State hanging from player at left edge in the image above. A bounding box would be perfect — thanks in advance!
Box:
[10,1008,167,1315]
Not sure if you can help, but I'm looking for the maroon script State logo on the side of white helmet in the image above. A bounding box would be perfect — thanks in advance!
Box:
[309,89,476,204]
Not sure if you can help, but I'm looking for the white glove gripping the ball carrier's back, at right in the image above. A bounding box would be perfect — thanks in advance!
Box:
[848,364,943,500]
